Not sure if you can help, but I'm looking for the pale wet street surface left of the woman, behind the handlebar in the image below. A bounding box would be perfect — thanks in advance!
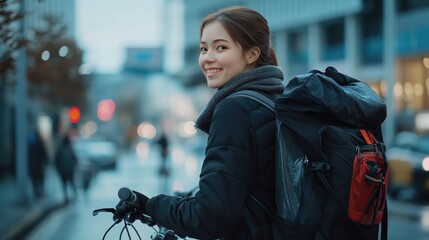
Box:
[26,143,200,240]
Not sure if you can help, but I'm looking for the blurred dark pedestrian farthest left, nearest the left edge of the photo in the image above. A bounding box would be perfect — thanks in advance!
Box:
[27,126,48,199]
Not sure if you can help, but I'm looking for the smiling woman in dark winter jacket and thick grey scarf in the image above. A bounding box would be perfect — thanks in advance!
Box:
[117,6,284,239]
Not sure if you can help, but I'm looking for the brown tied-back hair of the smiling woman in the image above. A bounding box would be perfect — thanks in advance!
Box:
[200,6,278,67]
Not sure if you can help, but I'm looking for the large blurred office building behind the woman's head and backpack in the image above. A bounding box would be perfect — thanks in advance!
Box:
[180,0,429,144]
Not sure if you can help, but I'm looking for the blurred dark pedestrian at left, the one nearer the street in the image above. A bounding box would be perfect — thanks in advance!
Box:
[54,130,77,203]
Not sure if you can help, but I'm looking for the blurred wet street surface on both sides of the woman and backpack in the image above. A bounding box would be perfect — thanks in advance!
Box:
[26,145,429,240]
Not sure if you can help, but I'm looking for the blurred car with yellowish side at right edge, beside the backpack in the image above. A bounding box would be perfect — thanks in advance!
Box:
[386,131,429,199]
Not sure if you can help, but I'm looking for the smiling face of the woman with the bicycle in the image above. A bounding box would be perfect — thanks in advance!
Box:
[198,22,248,88]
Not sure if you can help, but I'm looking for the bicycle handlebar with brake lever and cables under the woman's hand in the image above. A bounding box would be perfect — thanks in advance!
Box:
[92,187,180,240]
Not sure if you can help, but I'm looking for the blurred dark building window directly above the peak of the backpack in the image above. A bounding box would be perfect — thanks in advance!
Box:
[322,19,346,60]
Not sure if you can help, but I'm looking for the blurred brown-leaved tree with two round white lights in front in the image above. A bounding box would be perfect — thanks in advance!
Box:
[27,15,90,113]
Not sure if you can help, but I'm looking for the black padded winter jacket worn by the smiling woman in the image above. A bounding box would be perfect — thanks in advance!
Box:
[146,91,275,240]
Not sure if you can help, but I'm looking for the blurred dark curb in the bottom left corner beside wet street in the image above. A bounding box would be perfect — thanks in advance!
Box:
[0,203,67,240]
